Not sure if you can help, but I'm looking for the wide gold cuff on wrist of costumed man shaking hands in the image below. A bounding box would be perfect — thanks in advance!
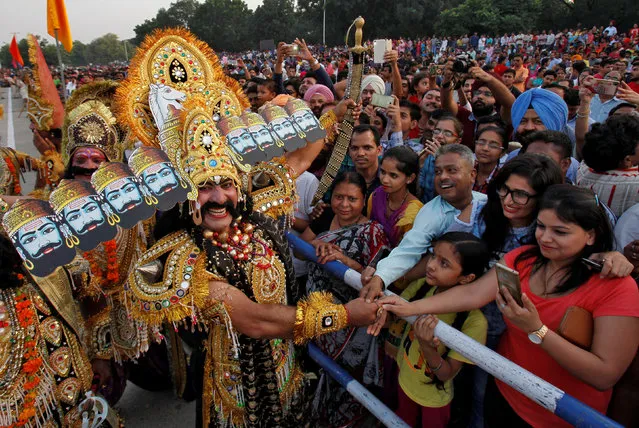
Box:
[293,292,348,345]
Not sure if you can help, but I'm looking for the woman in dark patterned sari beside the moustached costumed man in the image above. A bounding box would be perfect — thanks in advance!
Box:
[302,172,389,426]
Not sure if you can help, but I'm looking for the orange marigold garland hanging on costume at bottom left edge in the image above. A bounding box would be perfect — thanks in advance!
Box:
[15,291,42,426]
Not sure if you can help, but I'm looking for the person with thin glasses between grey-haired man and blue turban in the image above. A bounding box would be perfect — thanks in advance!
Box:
[473,126,508,194]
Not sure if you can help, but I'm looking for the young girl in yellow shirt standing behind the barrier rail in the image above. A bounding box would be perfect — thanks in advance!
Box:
[393,232,488,428]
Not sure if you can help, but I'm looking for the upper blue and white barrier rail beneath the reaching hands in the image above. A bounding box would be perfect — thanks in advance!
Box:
[287,232,622,428]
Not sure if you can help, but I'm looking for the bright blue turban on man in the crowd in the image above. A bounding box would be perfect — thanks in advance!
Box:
[511,88,568,131]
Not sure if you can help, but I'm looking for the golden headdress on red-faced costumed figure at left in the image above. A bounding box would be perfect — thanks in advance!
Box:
[62,81,130,164]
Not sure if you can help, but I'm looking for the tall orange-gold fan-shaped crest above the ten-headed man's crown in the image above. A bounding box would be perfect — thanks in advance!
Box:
[116,28,249,149]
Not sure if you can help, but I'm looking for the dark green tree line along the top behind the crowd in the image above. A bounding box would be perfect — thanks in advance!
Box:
[0,0,639,66]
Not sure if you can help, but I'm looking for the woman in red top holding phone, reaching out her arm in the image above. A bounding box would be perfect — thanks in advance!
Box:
[382,184,639,427]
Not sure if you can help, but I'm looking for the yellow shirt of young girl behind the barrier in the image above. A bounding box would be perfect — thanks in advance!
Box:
[397,285,488,408]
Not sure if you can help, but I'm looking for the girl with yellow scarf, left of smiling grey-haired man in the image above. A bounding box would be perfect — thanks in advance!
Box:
[366,146,424,247]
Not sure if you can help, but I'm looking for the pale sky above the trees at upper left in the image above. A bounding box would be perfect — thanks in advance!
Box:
[0,0,262,45]
